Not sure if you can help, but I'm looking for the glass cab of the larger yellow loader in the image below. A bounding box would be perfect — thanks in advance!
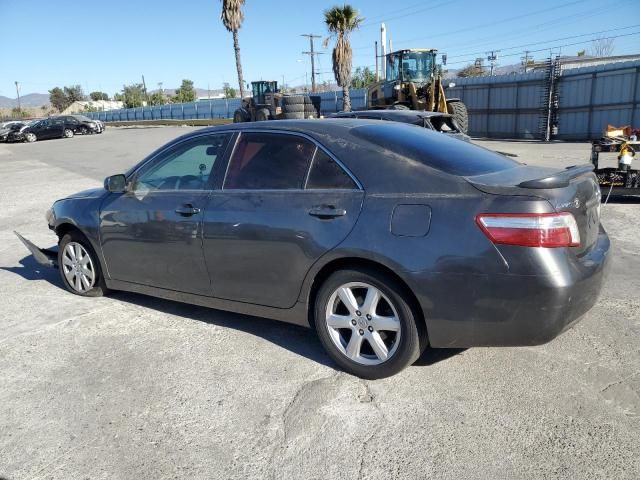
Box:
[386,49,437,84]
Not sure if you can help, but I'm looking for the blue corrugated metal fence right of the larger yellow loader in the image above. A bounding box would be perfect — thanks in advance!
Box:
[447,61,640,140]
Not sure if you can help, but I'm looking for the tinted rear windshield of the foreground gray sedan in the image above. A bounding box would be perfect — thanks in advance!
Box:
[351,122,519,177]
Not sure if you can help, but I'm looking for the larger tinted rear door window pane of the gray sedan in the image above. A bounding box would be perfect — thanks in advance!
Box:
[224,133,316,190]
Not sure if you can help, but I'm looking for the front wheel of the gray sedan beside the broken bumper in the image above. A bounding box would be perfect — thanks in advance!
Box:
[58,231,109,297]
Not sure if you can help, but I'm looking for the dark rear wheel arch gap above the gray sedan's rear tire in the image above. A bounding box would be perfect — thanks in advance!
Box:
[306,257,428,338]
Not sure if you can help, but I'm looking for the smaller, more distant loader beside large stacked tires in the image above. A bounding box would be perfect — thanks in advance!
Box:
[233,80,320,123]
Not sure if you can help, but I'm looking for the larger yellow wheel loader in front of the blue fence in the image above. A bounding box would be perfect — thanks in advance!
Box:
[367,48,469,133]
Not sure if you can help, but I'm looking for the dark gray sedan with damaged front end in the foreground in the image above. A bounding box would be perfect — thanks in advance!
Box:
[17,119,609,378]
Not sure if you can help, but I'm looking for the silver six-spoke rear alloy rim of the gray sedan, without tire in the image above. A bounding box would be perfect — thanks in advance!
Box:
[325,282,402,365]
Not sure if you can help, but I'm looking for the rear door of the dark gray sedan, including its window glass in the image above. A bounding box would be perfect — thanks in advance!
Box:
[203,131,364,308]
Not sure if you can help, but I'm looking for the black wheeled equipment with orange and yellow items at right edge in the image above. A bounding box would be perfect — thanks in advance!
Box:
[591,125,640,196]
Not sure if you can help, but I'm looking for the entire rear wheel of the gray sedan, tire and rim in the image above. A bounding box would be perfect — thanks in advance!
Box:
[314,269,426,380]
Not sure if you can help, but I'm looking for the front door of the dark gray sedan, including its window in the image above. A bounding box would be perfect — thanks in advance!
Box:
[100,134,231,295]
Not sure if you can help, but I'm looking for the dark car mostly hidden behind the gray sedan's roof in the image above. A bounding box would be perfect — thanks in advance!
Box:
[327,109,471,142]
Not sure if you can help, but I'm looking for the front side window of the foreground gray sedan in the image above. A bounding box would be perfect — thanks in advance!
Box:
[133,134,231,192]
